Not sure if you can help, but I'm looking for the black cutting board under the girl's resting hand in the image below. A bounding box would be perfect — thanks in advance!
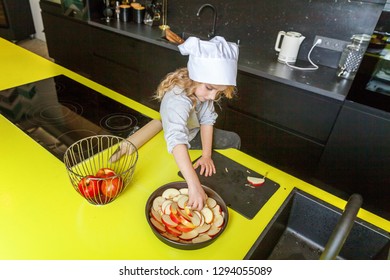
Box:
[179,151,280,219]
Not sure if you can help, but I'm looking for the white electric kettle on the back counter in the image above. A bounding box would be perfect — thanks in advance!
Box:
[275,31,306,63]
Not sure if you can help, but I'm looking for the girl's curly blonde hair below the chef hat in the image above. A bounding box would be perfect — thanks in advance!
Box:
[154,68,237,104]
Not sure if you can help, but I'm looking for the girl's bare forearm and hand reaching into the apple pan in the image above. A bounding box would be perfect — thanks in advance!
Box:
[172,144,207,210]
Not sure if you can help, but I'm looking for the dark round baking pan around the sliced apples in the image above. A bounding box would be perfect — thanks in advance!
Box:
[145,181,229,250]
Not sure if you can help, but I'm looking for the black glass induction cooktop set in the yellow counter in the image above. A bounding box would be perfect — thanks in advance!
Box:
[0,75,151,160]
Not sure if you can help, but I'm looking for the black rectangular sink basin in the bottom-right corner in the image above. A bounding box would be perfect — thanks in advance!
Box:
[245,189,390,260]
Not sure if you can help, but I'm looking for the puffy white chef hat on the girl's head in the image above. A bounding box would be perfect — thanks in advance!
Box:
[179,36,238,86]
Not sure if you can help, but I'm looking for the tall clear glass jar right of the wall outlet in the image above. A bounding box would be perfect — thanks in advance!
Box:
[337,34,371,80]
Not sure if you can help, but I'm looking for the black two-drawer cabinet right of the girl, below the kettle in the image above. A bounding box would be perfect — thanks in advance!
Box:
[224,72,342,179]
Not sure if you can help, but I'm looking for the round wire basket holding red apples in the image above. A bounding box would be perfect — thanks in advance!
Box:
[64,135,138,205]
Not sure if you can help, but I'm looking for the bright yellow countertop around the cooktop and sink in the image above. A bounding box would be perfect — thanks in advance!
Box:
[0,39,390,260]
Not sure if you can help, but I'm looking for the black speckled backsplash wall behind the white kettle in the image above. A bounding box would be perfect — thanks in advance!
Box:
[89,0,386,68]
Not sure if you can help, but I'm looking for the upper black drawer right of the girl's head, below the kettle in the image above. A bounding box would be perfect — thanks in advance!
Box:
[229,72,341,143]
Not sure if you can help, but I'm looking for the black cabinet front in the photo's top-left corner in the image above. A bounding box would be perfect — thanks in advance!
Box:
[0,0,35,41]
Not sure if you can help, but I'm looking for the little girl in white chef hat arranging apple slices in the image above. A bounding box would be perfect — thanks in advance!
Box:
[155,36,241,210]
